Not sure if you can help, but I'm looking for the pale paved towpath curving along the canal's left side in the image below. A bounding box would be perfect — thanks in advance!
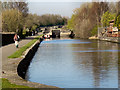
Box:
[0,33,56,88]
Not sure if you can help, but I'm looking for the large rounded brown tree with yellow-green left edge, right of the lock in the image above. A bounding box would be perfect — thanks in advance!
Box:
[68,2,108,38]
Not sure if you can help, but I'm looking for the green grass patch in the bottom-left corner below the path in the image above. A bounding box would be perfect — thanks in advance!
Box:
[2,78,30,88]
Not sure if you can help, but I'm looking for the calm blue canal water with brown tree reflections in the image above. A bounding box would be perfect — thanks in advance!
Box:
[26,39,120,88]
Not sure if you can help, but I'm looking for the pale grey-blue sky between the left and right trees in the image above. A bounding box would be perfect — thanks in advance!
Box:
[28,2,83,18]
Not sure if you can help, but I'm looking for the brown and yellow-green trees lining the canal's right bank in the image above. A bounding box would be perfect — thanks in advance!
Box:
[67,2,120,38]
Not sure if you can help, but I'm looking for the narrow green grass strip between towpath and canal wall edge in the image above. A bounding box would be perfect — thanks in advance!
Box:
[8,35,42,58]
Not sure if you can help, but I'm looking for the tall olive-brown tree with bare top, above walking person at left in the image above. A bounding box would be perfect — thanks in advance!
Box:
[2,0,28,36]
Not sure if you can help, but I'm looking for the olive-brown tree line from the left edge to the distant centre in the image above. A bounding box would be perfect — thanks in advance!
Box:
[0,2,67,34]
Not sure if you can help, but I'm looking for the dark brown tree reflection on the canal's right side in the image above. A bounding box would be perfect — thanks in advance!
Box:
[71,41,118,87]
